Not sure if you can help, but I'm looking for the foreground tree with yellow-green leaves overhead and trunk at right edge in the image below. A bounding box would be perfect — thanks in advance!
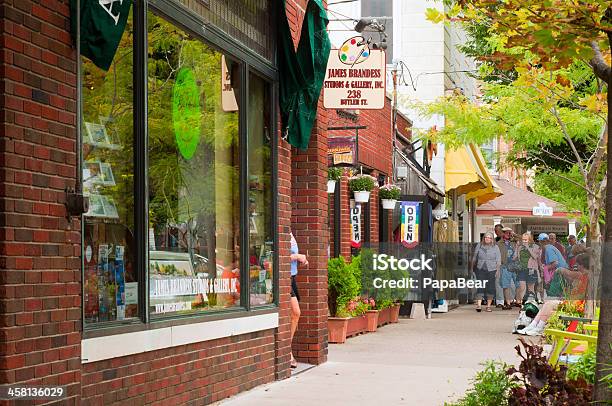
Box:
[428,0,612,401]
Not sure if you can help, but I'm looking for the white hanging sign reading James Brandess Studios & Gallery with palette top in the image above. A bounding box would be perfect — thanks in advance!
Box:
[323,37,386,110]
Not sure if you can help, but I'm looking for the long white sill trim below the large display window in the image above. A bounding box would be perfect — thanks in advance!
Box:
[81,313,278,364]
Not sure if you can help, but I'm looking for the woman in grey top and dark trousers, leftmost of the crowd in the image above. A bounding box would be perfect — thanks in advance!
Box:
[470,232,501,312]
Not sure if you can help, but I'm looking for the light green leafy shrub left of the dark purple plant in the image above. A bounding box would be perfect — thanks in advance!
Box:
[445,361,518,406]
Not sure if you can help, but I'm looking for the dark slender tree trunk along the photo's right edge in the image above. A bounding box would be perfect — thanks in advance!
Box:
[593,28,612,403]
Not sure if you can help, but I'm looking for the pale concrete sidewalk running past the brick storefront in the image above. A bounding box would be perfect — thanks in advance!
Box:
[221,306,519,406]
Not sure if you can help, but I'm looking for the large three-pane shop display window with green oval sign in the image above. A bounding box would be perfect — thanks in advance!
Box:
[80,2,277,330]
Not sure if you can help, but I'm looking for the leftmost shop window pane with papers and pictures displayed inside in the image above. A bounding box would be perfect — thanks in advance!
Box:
[81,12,139,325]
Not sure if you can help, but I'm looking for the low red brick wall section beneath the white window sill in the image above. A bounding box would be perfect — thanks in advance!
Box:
[82,330,276,405]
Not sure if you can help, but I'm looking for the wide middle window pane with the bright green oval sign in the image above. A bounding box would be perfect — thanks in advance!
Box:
[148,13,241,315]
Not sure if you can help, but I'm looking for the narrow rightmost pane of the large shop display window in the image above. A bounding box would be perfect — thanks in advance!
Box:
[248,73,274,306]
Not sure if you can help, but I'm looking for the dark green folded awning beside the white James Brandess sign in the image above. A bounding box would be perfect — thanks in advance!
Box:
[278,0,331,149]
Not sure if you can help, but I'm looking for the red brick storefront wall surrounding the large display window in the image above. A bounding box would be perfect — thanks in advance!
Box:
[0,0,296,405]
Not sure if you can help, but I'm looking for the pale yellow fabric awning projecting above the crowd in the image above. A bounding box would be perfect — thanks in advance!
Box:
[445,144,502,204]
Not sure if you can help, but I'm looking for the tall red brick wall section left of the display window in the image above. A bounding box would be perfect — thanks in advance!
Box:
[0,0,81,403]
